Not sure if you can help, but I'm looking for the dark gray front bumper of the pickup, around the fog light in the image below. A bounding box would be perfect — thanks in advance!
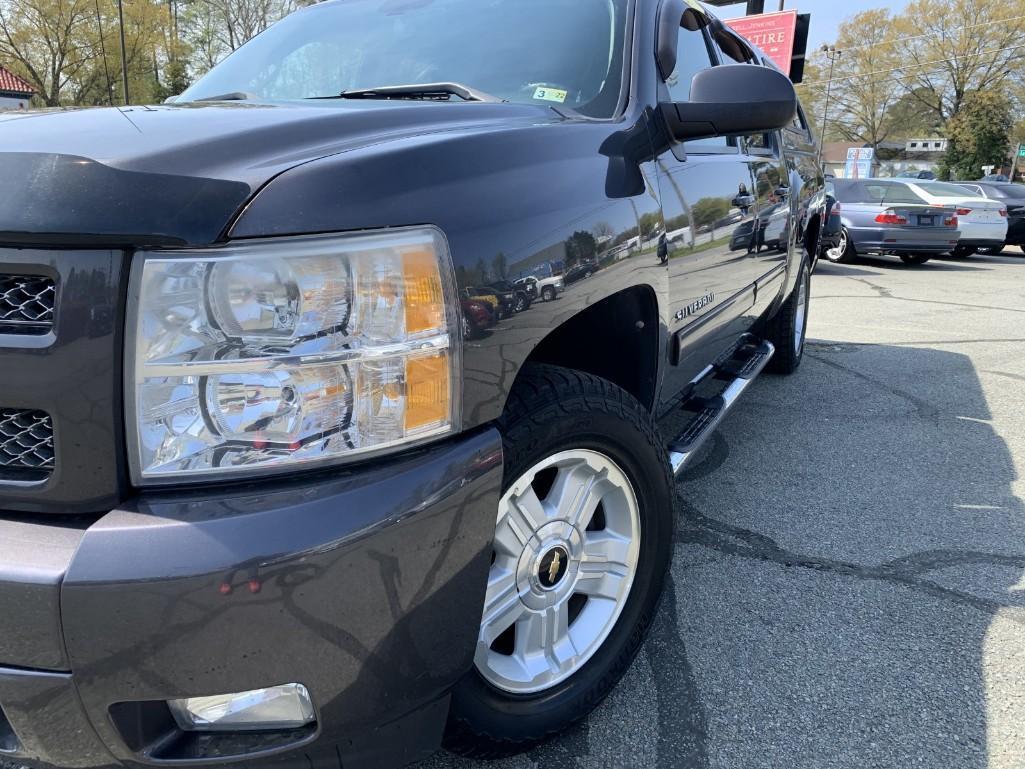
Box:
[0,430,502,769]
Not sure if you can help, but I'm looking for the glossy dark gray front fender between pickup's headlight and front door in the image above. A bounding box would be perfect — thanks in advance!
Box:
[231,113,668,429]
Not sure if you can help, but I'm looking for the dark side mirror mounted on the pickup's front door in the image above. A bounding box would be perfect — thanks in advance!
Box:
[660,65,797,141]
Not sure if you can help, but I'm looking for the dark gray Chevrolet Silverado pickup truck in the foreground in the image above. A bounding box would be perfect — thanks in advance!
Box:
[0,0,825,769]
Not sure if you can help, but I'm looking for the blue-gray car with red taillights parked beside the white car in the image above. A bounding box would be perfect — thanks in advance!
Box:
[825,178,960,265]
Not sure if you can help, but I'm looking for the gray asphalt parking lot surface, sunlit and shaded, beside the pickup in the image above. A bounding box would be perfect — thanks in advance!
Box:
[422,249,1025,769]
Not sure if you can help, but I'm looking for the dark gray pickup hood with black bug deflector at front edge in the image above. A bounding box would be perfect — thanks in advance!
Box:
[0,102,555,246]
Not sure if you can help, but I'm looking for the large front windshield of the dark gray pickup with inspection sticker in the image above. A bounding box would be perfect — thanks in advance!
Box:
[178,0,628,117]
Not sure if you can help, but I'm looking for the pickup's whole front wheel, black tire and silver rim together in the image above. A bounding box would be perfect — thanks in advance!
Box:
[445,366,675,758]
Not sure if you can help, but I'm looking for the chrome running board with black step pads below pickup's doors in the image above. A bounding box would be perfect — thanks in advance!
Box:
[668,338,776,476]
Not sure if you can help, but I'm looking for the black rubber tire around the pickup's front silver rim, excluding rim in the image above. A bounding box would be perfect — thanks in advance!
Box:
[444,365,677,759]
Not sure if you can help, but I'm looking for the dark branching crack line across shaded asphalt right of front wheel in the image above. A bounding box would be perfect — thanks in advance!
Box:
[675,501,1025,626]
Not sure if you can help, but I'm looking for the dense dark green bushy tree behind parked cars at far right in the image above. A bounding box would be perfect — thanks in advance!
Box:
[940,90,1014,178]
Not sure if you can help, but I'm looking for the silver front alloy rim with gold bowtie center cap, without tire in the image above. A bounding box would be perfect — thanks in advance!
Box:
[475,449,641,694]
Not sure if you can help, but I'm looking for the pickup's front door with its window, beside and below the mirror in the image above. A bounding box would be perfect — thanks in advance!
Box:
[656,18,757,398]
